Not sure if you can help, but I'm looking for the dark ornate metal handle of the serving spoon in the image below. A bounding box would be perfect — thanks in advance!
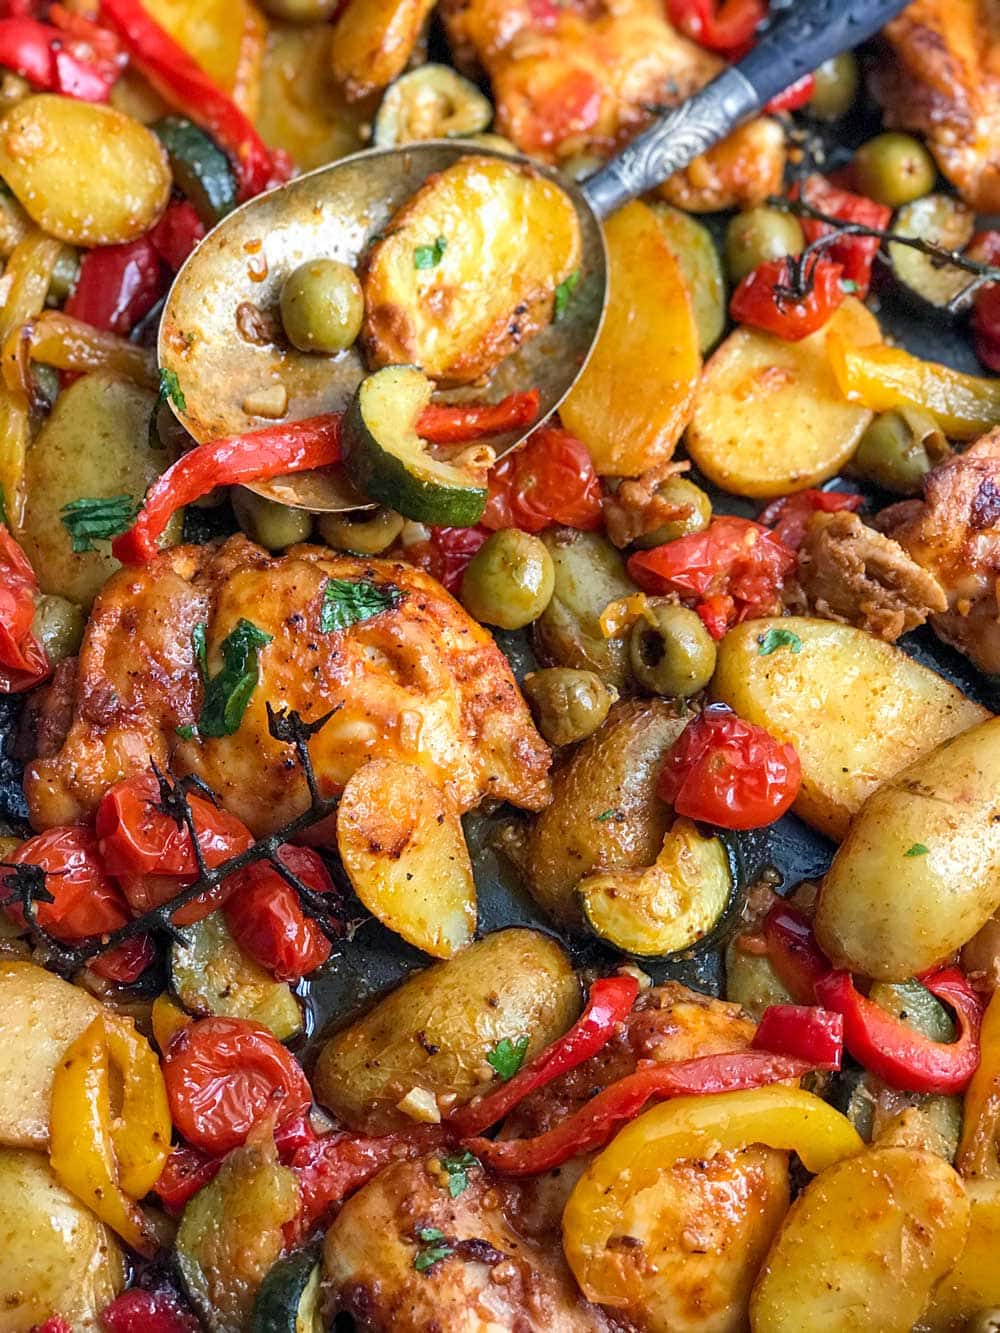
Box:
[583,0,907,217]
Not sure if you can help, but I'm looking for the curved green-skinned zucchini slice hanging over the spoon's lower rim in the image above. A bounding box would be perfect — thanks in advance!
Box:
[341,365,492,528]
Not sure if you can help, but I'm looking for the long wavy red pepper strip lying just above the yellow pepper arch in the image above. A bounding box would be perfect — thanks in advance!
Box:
[464,1050,817,1176]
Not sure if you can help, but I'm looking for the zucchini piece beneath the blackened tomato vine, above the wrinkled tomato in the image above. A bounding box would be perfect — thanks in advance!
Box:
[169,912,303,1041]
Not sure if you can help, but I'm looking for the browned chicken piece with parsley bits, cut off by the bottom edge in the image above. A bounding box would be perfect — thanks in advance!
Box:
[324,1158,616,1333]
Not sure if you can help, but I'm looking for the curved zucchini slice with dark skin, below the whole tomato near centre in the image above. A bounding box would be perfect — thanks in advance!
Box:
[576,818,735,957]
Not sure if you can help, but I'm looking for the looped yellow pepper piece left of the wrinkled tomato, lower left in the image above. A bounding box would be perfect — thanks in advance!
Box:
[49,1013,171,1256]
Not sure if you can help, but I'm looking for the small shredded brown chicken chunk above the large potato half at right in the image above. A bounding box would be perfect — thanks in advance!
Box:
[797,509,948,643]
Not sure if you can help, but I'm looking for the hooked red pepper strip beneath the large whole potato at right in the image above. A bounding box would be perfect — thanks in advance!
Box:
[816,968,983,1094]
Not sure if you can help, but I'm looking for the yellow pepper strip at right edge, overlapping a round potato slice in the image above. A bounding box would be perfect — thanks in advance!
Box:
[827,333,1000,440]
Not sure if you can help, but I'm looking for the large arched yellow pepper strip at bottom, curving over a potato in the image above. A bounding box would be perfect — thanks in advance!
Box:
[563,1085,864,1306]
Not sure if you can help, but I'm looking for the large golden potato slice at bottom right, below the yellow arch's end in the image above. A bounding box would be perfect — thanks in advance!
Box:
[751,1148,969,1333]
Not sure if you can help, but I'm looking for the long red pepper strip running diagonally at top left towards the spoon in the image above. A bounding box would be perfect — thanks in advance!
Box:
[100,0,289,200]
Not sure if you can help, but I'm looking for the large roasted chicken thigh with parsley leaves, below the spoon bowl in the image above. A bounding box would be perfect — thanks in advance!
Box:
[25,537,549,833]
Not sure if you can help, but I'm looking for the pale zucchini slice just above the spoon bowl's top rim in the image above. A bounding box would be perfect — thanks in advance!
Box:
[372,64,493,148]
